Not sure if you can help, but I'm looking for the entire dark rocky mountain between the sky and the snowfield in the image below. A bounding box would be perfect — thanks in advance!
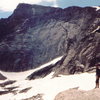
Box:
[0,4,100,73]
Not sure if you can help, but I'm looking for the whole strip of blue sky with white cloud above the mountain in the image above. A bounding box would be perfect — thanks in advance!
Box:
[0,0,100,18]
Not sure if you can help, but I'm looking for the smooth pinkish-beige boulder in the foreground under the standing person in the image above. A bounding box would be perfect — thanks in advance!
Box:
[54,89,100,100]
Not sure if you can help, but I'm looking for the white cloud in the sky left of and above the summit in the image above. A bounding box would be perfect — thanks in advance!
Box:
[0,0,58,11]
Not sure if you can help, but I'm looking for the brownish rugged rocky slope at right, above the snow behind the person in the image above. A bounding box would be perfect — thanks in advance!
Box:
[52,10,100,75]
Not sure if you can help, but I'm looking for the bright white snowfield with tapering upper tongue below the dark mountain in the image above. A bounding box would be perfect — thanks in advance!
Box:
[0,57,95,100]
